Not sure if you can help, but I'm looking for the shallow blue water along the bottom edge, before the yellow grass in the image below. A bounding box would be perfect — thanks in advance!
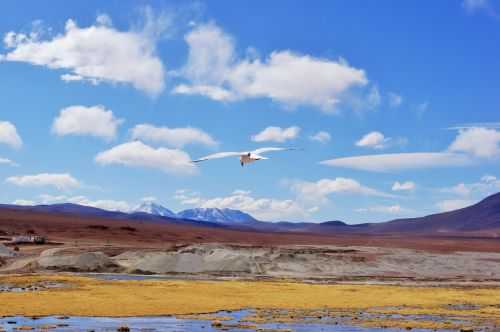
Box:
[0,310,440,332]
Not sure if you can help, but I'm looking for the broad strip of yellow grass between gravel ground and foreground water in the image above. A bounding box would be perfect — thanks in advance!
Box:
[0,275,500,324]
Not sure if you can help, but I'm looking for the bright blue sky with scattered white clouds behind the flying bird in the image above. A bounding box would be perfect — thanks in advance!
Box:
[0,0,500,223]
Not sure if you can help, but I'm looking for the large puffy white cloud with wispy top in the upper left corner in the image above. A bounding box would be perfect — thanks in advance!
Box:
[2,15,165,95]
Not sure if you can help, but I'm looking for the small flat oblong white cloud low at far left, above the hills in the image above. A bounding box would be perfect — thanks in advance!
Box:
[5,173,81,190]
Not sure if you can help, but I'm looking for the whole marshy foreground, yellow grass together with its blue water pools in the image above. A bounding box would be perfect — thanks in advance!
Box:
[0,274,500,332]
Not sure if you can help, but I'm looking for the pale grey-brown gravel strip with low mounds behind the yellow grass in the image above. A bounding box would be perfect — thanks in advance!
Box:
[0,244,500,281]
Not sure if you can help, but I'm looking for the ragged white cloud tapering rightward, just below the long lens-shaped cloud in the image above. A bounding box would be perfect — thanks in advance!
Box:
[290,177,392,203]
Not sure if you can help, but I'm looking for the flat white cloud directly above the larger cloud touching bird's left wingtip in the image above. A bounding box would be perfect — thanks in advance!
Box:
[132,123,218,148]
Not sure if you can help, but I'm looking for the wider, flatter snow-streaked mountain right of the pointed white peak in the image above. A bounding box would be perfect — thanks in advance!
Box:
[177,208,257,224]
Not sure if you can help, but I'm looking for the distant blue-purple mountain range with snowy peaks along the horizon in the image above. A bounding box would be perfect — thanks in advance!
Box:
[0,193,500,236]
